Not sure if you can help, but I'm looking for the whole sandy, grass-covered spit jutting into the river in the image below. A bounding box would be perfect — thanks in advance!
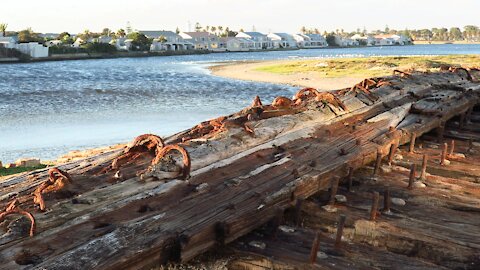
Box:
[210,55,480,90]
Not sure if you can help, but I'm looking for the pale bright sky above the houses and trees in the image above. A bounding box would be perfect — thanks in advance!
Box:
[0,0,480,33]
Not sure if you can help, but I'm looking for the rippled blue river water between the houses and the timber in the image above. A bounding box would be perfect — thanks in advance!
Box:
[0,45,480,162]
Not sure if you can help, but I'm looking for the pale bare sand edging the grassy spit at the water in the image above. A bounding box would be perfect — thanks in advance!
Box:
[210,59,361,90]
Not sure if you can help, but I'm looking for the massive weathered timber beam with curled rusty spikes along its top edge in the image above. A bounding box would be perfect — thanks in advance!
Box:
[0,70,480,269]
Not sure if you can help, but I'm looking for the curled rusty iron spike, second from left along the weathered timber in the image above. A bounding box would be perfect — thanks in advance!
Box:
[32,168,72,211]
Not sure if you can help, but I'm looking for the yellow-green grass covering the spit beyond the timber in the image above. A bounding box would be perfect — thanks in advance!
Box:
[255,55,480,78]
